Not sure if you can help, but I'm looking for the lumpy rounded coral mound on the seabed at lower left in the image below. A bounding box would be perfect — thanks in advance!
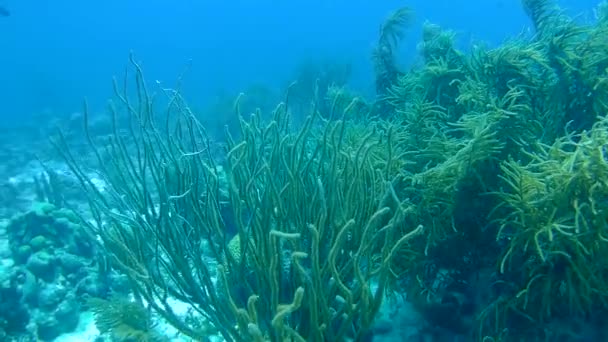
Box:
[0,203,124,341]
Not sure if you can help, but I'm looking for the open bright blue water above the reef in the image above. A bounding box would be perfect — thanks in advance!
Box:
[0,0,598,124]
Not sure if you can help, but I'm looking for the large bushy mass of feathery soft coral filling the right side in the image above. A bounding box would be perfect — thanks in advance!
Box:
[376,1,607,338]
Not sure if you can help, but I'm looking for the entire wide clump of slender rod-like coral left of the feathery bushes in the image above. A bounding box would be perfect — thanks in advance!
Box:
[55,54,423,341]
